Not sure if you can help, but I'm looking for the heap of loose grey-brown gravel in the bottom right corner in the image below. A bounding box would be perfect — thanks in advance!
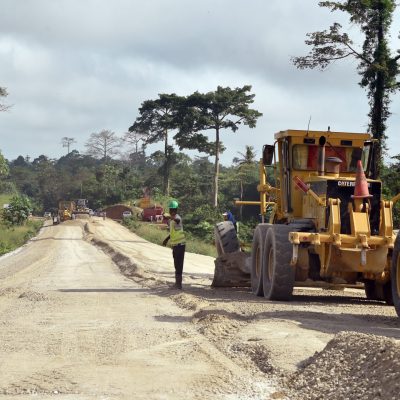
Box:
[287,332,400,400]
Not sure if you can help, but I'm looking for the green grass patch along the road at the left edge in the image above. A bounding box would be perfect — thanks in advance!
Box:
[0,220,43,255]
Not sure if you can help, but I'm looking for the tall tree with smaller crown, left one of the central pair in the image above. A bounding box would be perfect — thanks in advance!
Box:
[129,93,184,196]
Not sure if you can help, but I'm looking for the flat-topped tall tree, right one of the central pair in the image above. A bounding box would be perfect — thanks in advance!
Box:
[175,85,262,207]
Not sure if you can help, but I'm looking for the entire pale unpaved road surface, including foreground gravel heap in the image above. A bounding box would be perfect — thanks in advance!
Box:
[0,218,400,400]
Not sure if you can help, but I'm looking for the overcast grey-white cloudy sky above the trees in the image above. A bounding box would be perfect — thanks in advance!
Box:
[0,0,400,164]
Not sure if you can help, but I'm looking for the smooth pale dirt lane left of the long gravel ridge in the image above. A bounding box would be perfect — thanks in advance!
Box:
[0,221,276,399]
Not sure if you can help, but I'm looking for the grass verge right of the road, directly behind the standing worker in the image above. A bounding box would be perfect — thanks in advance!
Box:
[124,219,217,257]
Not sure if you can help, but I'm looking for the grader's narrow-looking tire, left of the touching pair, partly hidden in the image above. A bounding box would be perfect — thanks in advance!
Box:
[250,224,272,296]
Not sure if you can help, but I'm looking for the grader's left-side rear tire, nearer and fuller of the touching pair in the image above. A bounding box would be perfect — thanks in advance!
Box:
[262,225,297,301]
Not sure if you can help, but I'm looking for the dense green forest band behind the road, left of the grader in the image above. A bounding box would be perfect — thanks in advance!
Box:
[5,149,258,230]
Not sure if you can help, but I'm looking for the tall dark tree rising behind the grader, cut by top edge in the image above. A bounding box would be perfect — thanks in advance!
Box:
[293,0,400,178]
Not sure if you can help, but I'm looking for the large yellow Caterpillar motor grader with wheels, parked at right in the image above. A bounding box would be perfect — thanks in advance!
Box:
[215,129,400,316]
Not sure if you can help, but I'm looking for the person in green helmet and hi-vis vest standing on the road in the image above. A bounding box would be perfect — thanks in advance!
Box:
[163,200,186,289]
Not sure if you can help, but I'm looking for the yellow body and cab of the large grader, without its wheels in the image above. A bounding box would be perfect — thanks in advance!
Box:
[236,130,398,286]
